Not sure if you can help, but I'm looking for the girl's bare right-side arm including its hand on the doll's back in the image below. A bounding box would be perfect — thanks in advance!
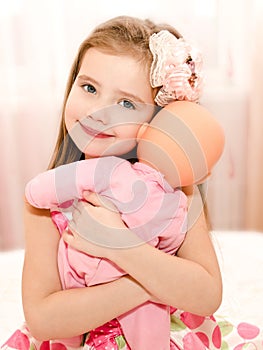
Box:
[64,192,222,316]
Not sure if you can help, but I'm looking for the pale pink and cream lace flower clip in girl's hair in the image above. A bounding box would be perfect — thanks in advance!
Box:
[149,30,203,107]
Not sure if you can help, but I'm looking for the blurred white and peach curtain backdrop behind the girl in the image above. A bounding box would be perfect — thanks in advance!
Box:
[0,0,263,250]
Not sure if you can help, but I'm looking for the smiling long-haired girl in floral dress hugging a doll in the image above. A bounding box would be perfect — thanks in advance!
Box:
[3,17,262,350]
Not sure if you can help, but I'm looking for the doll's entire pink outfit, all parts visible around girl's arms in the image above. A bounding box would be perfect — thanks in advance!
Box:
[26,157,186,350]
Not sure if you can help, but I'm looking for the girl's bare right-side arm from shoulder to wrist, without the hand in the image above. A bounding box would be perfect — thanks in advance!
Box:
[111,188,222,316]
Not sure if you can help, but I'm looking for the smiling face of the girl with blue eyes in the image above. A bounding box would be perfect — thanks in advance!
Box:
[65,48,155,158]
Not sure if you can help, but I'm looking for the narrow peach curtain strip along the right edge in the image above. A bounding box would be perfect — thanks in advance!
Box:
[245,1,263,231]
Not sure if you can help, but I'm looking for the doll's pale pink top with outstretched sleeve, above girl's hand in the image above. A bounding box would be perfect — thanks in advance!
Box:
[25,156,187,254]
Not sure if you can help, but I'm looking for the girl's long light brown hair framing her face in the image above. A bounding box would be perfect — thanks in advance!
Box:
[49,16,182,168]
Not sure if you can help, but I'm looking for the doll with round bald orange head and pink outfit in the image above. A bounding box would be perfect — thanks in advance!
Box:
[25,97,227,349]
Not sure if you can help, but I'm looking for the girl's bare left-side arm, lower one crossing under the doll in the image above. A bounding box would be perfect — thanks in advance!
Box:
[22,203,149,340]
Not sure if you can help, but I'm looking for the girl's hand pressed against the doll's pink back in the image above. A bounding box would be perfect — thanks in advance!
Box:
[63,192,142,259]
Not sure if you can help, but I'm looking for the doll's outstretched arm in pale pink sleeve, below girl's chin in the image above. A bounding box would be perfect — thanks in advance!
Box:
[25,157,123,209]
